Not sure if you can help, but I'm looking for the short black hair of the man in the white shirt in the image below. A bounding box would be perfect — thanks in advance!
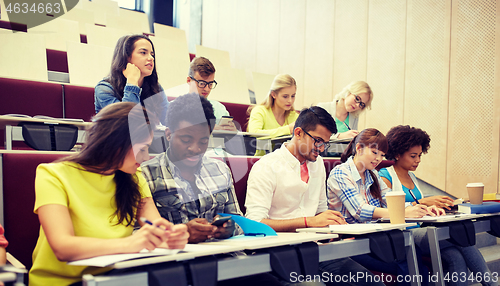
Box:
[293,106,337,133]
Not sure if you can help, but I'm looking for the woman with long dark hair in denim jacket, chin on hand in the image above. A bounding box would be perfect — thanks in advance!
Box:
[94,35,168,125]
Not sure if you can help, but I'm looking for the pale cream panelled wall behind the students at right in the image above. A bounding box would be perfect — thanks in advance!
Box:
[201,0,500,196]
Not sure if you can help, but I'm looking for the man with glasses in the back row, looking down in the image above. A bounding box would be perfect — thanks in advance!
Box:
[187,57,236,131]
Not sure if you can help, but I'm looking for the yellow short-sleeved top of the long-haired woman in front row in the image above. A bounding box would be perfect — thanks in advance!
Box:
[29,162,151,286]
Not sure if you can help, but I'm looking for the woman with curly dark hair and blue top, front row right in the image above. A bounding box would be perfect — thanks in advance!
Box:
[380,125,498,285]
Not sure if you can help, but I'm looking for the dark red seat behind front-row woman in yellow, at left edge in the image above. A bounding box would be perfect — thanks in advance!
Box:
[2,153,70,269]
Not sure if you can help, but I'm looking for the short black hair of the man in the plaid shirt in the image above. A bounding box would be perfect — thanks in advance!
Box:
[167,93,215,133]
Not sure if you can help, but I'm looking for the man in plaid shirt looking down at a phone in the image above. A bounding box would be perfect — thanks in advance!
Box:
[142,94,242,243]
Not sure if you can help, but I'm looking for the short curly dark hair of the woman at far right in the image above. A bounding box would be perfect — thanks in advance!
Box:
[385,125,431,160]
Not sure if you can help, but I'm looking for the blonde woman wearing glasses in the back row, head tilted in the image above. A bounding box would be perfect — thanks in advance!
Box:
[318,81,373,139]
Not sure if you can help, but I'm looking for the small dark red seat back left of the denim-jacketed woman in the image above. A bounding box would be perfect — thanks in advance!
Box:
[64,85,95,122]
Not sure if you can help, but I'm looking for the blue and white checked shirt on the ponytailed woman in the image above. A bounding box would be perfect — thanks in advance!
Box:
[327,157,390,223]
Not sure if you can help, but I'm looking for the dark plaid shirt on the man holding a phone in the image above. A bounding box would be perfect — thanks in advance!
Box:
[141,149,242,224]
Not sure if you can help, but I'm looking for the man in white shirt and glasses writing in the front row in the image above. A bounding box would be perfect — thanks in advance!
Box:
[245,106,383,285]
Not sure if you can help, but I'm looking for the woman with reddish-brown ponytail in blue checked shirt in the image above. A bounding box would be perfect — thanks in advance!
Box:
[327,128,440,282]
